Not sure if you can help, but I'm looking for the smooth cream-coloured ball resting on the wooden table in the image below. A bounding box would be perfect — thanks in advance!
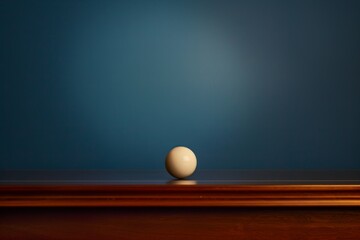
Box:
[165,147,197,178]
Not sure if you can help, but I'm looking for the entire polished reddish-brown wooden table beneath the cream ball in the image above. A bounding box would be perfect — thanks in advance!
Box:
[0,170,360,240]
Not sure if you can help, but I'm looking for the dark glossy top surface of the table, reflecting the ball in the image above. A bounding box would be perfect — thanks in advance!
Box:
[0,170,360,186]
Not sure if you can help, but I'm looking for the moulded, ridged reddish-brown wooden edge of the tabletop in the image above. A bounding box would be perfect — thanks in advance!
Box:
[0,185,360,207]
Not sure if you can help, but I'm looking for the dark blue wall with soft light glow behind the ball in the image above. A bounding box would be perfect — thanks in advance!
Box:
[0,0,360,169]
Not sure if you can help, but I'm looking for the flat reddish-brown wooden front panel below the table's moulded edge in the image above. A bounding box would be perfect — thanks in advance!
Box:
[0,207,360,240]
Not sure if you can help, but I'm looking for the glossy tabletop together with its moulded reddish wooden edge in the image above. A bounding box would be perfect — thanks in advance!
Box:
[0,170,360,207]
